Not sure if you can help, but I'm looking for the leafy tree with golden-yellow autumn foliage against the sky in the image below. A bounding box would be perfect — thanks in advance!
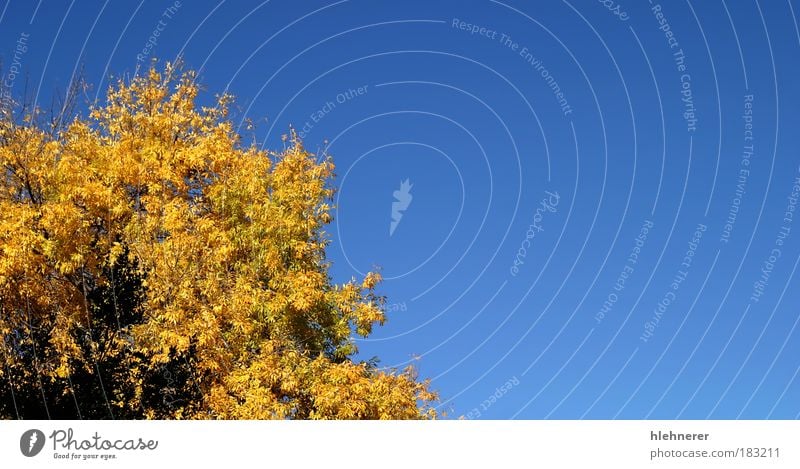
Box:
[0,64,436,419]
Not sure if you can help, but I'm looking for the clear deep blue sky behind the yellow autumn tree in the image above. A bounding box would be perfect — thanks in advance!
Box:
[0,0,800,419]
